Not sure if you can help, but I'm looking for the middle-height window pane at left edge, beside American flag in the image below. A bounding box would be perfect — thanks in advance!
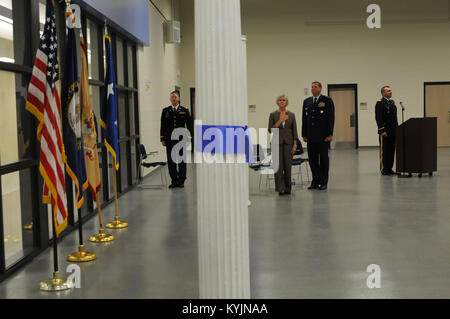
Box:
[0,71,36,165]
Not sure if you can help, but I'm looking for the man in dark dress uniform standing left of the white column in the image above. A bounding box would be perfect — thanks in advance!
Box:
[160,91,193,188]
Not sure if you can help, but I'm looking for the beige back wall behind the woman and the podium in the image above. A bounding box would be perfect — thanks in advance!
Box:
[181,0,450,146]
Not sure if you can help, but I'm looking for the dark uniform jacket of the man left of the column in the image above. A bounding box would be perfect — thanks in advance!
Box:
[160,105,193,142]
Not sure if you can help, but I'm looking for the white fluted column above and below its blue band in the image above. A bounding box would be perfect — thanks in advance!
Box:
[195,0,250,298]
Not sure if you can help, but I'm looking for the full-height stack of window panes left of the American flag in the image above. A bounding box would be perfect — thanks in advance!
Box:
[0,0,39,274]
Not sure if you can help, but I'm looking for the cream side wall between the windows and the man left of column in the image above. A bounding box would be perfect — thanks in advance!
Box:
[137,0,181,174]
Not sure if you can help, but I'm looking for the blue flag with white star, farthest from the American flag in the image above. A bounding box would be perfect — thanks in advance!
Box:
[100,35,119,170]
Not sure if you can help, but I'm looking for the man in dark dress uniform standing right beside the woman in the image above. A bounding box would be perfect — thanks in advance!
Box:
[302,81,334,190]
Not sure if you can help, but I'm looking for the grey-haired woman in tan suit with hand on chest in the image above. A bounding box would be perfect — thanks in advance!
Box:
[269,94,298,196]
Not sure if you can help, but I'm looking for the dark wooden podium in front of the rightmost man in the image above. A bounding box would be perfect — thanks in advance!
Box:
[396,117,437,177]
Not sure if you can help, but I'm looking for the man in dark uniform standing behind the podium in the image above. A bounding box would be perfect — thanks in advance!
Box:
[375,86,398,175]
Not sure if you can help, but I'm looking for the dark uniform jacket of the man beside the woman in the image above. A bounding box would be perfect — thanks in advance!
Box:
[302,95,334,142]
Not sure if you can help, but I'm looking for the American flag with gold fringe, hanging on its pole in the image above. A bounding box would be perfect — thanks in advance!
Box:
[26,0,67,236]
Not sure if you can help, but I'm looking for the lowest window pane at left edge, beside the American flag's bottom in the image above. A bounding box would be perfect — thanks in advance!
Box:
[1,169,34,268]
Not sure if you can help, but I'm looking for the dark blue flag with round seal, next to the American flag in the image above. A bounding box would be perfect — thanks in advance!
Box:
[61,29,88,208]
